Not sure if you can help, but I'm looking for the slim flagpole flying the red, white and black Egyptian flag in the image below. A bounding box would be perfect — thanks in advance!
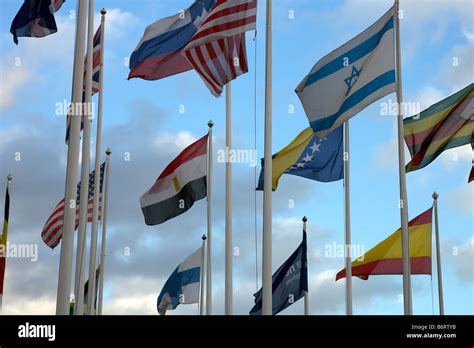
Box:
[206,121,214,315]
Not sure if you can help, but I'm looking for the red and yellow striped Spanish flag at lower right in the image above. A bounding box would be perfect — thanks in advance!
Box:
[336,208,432,281]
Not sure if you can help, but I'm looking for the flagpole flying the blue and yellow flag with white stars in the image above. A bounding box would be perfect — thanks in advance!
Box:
[344,121,352,315]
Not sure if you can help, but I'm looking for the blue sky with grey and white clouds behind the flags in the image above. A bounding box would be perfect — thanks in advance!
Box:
[0,0,474,315]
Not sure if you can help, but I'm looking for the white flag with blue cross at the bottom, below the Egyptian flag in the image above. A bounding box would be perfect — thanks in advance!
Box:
[156,247,202,315]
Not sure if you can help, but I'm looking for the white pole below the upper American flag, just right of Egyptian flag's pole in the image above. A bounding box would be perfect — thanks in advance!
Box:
[225,82,233,315]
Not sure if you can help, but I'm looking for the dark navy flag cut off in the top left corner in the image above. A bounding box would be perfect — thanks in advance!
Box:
[10,0,64,45]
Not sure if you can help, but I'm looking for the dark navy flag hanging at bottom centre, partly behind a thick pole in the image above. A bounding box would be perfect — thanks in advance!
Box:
[250,231,308,315]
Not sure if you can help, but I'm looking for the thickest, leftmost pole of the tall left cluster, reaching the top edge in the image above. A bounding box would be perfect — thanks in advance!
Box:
[56,0,86,315]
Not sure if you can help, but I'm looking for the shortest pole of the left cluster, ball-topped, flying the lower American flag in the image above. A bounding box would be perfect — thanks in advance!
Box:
[97,149,112,315]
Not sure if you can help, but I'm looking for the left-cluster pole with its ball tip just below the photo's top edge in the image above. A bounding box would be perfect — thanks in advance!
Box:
[87,9,106,315]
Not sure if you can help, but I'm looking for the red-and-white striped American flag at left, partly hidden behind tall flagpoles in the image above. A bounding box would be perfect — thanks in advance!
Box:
[41,163,105,249]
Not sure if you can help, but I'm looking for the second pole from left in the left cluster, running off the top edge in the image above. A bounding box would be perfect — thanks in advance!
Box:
[74,0,94,315]
